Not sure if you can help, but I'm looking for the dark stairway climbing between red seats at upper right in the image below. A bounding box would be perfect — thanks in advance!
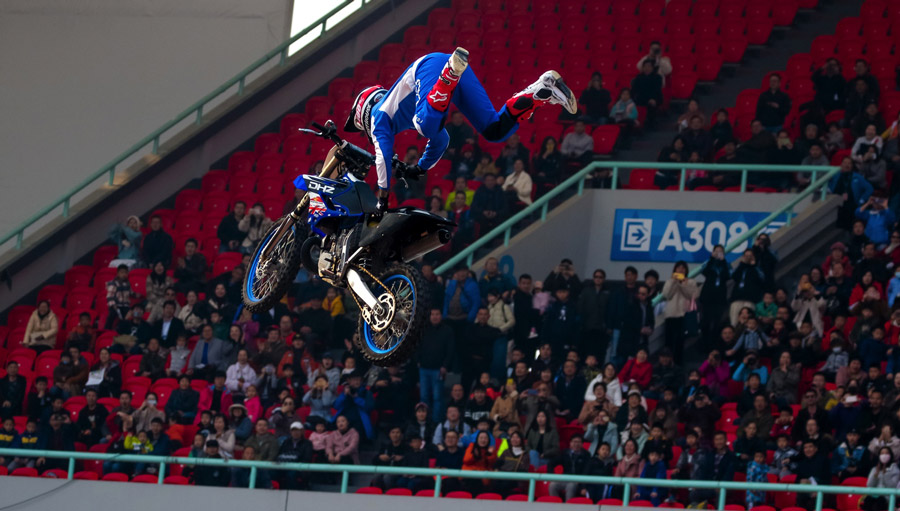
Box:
[617,0,863,161]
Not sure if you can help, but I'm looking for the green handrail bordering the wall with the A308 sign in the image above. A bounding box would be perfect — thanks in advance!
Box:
[434,161,840,274]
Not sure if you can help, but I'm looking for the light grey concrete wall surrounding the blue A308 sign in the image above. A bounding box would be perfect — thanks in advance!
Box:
[474,190,809,280]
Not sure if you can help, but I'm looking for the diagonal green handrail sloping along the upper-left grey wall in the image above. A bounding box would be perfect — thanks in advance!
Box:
[0,0,372,250]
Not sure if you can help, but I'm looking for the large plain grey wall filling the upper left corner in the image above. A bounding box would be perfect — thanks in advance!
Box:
[0,0,290,234]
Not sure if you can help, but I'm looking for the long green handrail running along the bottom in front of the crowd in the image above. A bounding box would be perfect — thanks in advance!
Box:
[0,449,900,511]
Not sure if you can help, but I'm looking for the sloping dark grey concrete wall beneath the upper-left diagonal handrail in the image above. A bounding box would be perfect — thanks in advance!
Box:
[0,0,438,311]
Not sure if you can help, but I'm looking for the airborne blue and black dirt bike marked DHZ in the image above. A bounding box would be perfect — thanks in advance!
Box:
[243,121,456,366]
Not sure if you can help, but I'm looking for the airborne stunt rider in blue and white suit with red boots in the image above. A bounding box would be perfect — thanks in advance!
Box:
[344,48,578,213]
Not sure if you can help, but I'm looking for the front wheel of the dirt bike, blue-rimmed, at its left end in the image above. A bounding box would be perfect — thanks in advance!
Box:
[242,216,302,313]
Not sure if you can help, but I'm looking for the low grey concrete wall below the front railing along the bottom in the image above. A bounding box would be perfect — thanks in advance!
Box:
[0,477,576,511]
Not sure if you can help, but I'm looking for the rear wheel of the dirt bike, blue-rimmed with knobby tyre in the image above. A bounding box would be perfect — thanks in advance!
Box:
[358,264,429,367]
